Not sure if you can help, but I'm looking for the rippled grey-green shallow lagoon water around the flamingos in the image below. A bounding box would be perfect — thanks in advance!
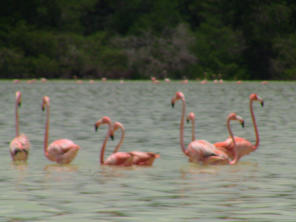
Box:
[0,81,296,221]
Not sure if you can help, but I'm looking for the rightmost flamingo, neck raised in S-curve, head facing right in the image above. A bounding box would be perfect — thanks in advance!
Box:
[214,93,264,160]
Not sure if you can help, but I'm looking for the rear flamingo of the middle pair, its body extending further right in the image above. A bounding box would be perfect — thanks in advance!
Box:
[113,122,159,166]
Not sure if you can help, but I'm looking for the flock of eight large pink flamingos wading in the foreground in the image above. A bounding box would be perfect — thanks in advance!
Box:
[10,88,264,167]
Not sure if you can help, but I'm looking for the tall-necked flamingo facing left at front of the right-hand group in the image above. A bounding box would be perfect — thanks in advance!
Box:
[171,92,228,164]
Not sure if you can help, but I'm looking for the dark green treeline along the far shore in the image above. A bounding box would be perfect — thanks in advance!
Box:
[0,0,296,80]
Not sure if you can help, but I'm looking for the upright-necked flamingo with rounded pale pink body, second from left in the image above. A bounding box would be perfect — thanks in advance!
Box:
[42,96,80,164]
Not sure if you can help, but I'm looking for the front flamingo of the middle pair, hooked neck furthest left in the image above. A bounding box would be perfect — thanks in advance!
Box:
[95,116,133,166]
